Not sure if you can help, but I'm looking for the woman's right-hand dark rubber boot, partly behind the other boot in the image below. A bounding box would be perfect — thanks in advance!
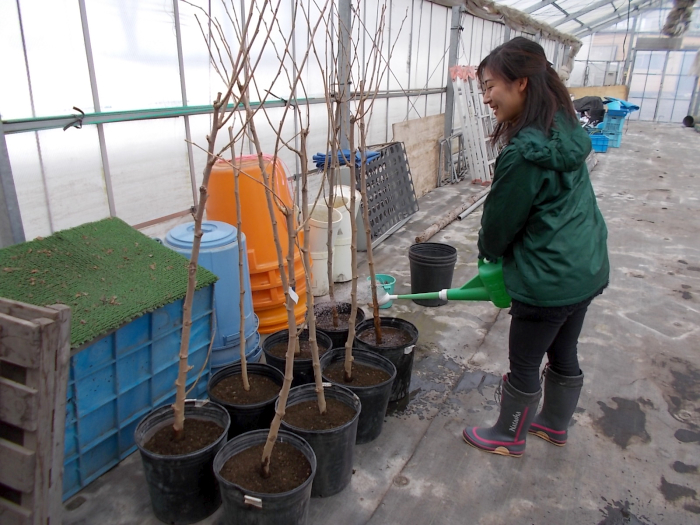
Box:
[528,366,583,447]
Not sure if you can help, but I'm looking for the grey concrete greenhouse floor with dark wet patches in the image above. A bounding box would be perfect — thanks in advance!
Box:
[63,122,700,525]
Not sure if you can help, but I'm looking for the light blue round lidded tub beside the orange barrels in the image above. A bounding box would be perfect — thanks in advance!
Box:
[164,221,262,375]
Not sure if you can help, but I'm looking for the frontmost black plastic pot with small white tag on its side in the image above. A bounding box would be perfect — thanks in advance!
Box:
[214,430,316,525]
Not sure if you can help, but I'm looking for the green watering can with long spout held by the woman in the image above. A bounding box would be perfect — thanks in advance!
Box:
[389,259,511,308]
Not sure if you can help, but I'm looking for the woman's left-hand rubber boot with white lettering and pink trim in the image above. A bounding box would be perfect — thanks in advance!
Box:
[462,376,542,458]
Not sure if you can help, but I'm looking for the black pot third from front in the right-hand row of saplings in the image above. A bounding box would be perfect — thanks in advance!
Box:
[321,348,396,445]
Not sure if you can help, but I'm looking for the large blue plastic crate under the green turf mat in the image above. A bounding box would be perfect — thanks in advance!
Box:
[63,286,214,500]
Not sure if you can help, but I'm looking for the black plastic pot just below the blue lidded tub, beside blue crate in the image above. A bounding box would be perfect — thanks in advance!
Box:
[207,363,284,439]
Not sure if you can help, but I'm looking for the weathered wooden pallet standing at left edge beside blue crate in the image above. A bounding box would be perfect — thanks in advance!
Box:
[0,298,71,525]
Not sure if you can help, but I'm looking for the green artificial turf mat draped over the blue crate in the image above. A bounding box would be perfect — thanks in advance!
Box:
[0,218,217,348]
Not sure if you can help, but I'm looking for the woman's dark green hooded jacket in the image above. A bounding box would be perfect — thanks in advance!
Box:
[478,112,610,306]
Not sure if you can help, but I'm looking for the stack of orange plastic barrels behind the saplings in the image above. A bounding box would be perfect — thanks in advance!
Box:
[206,155,306,334]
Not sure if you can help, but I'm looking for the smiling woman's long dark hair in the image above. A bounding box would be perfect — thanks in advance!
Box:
[477,36,576,144]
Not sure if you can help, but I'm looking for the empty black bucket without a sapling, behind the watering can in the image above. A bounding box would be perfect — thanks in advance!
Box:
[408,242,457,306]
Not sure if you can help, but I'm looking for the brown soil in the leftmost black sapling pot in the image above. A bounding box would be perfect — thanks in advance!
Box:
[144,417,224,456]
